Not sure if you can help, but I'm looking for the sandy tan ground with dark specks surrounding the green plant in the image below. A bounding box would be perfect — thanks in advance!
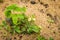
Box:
[0,0,60,40]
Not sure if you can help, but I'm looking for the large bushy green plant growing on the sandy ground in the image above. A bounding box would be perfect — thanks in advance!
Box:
[2,4,40,34]
